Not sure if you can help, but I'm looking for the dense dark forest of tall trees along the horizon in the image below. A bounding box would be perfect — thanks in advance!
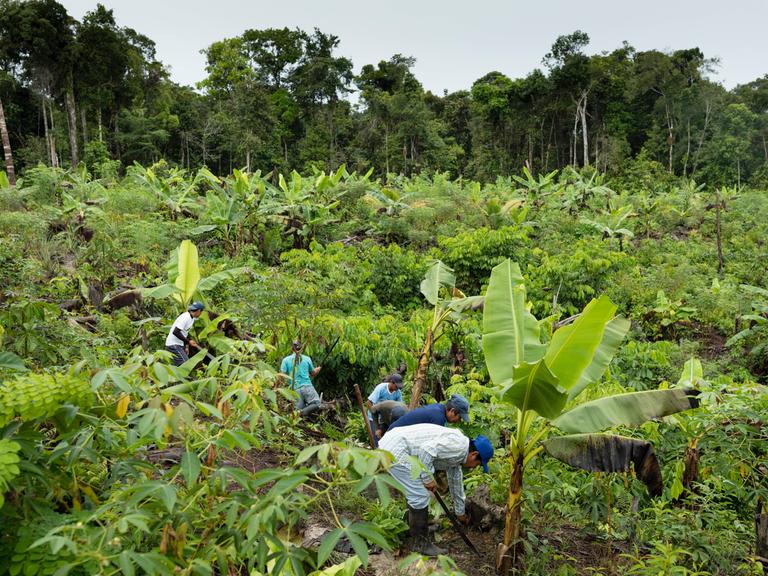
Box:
[0,0,768,185]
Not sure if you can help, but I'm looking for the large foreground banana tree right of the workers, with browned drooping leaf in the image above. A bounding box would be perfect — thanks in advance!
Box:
[483,260,697,574]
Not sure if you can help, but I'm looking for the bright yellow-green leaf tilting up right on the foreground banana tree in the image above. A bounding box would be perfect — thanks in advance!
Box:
[544,296,616,390]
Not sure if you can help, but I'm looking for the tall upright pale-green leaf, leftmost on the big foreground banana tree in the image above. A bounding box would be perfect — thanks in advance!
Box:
[483,260,545,383]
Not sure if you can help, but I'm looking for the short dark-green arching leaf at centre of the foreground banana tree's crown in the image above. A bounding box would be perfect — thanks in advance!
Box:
[501,359,568,418]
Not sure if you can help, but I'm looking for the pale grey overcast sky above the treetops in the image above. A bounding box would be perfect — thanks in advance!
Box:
[59,0,768,94]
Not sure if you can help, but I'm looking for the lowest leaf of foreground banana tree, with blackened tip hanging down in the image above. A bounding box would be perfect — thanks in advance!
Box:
[543,434,664,496]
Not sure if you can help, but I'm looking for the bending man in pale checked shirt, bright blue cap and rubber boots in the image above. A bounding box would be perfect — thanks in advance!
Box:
[379,424,493,556]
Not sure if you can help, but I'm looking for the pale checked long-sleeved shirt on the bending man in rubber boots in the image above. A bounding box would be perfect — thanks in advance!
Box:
[379,424,469,515]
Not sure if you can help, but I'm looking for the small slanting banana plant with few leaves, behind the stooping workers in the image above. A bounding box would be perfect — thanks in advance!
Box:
[410,260,483,408]
